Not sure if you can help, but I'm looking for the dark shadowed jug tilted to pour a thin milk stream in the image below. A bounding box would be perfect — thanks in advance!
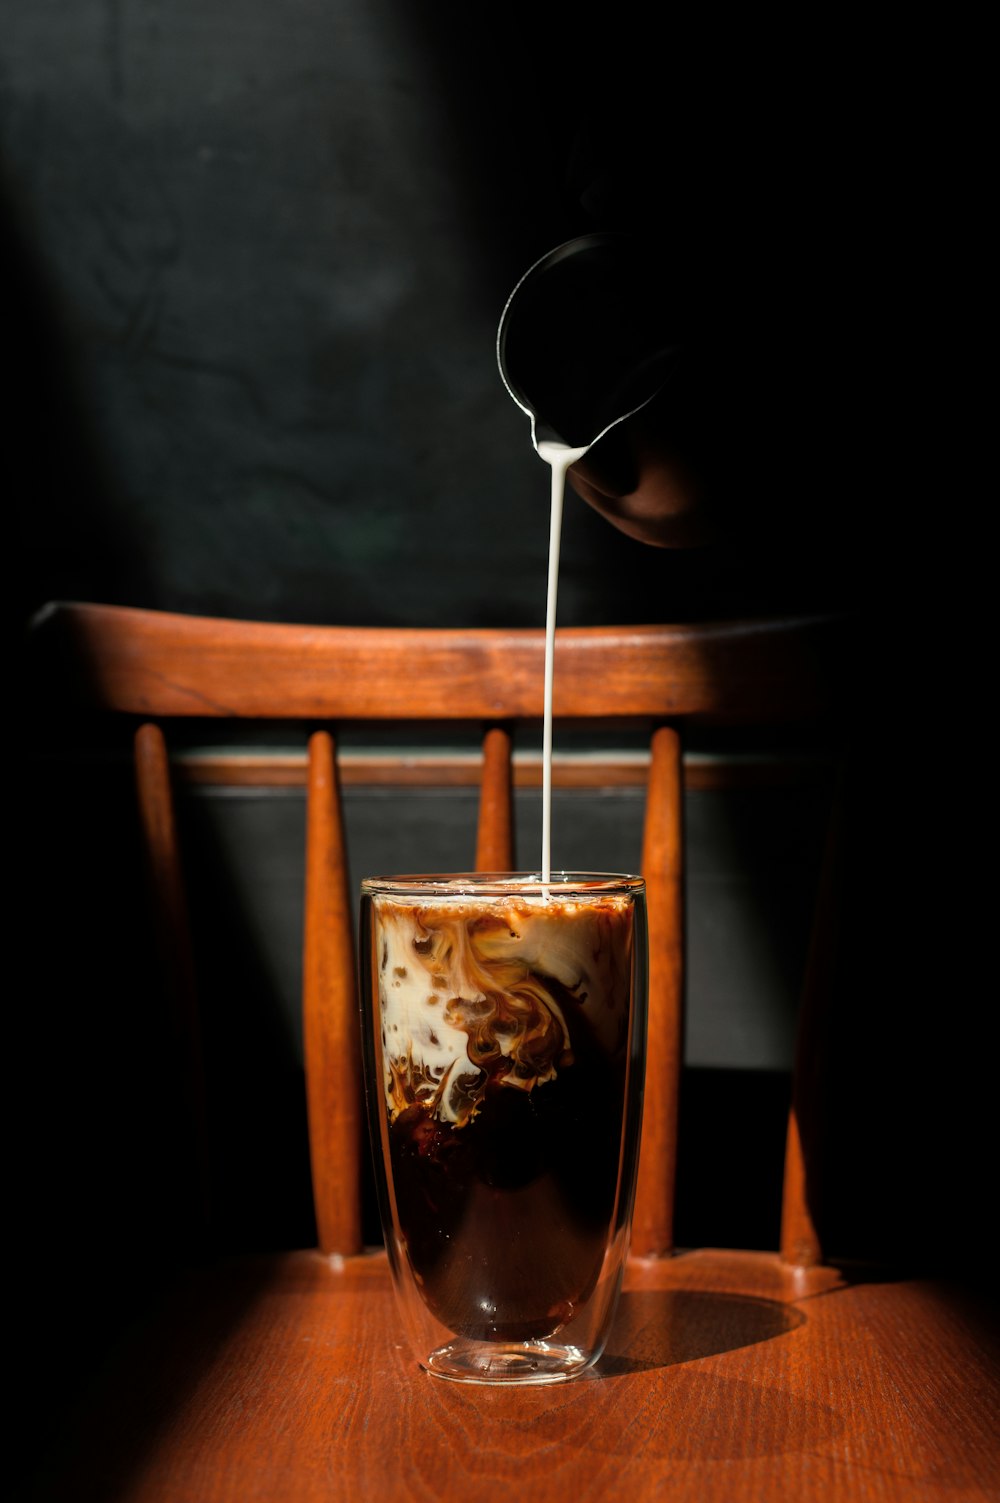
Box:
[496,231,714,547]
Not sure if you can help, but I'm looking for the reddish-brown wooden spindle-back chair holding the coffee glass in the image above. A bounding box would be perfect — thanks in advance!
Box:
[19,606,998,1503]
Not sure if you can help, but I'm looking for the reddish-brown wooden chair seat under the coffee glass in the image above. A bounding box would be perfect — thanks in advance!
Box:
[33,1250,1000,1503]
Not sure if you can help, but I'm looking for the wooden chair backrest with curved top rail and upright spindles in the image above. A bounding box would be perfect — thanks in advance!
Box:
[33,604,841,1263]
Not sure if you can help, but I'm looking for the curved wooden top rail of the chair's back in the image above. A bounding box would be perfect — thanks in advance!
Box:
[32,601,844,721]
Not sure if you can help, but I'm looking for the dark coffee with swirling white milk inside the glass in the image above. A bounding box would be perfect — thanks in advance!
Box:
[370,882,633,1341]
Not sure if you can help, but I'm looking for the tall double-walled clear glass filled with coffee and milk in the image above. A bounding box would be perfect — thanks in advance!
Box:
[361,872,647,1383]
